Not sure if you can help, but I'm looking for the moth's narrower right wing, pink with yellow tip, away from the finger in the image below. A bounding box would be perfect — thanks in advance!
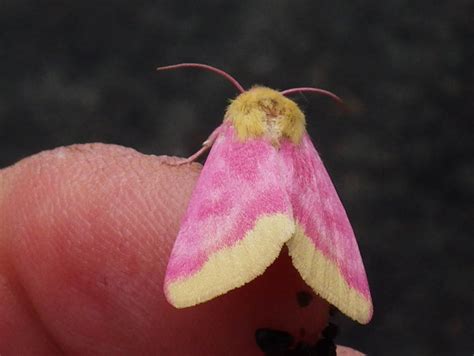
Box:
[280,134,373,324]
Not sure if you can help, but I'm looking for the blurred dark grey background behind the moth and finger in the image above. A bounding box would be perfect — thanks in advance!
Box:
[0,0,474,355]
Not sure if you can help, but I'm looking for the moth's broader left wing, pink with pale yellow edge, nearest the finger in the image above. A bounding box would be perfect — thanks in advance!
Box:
[165,124,295,308]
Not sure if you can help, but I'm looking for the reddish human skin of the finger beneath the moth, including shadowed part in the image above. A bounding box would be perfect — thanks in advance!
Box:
[0,144,359,356]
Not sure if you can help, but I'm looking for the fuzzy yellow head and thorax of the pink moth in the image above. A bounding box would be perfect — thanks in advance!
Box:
[225,87,306,146]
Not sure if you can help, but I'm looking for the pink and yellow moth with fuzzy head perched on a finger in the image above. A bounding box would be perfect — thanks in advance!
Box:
[158,63,373,324]
